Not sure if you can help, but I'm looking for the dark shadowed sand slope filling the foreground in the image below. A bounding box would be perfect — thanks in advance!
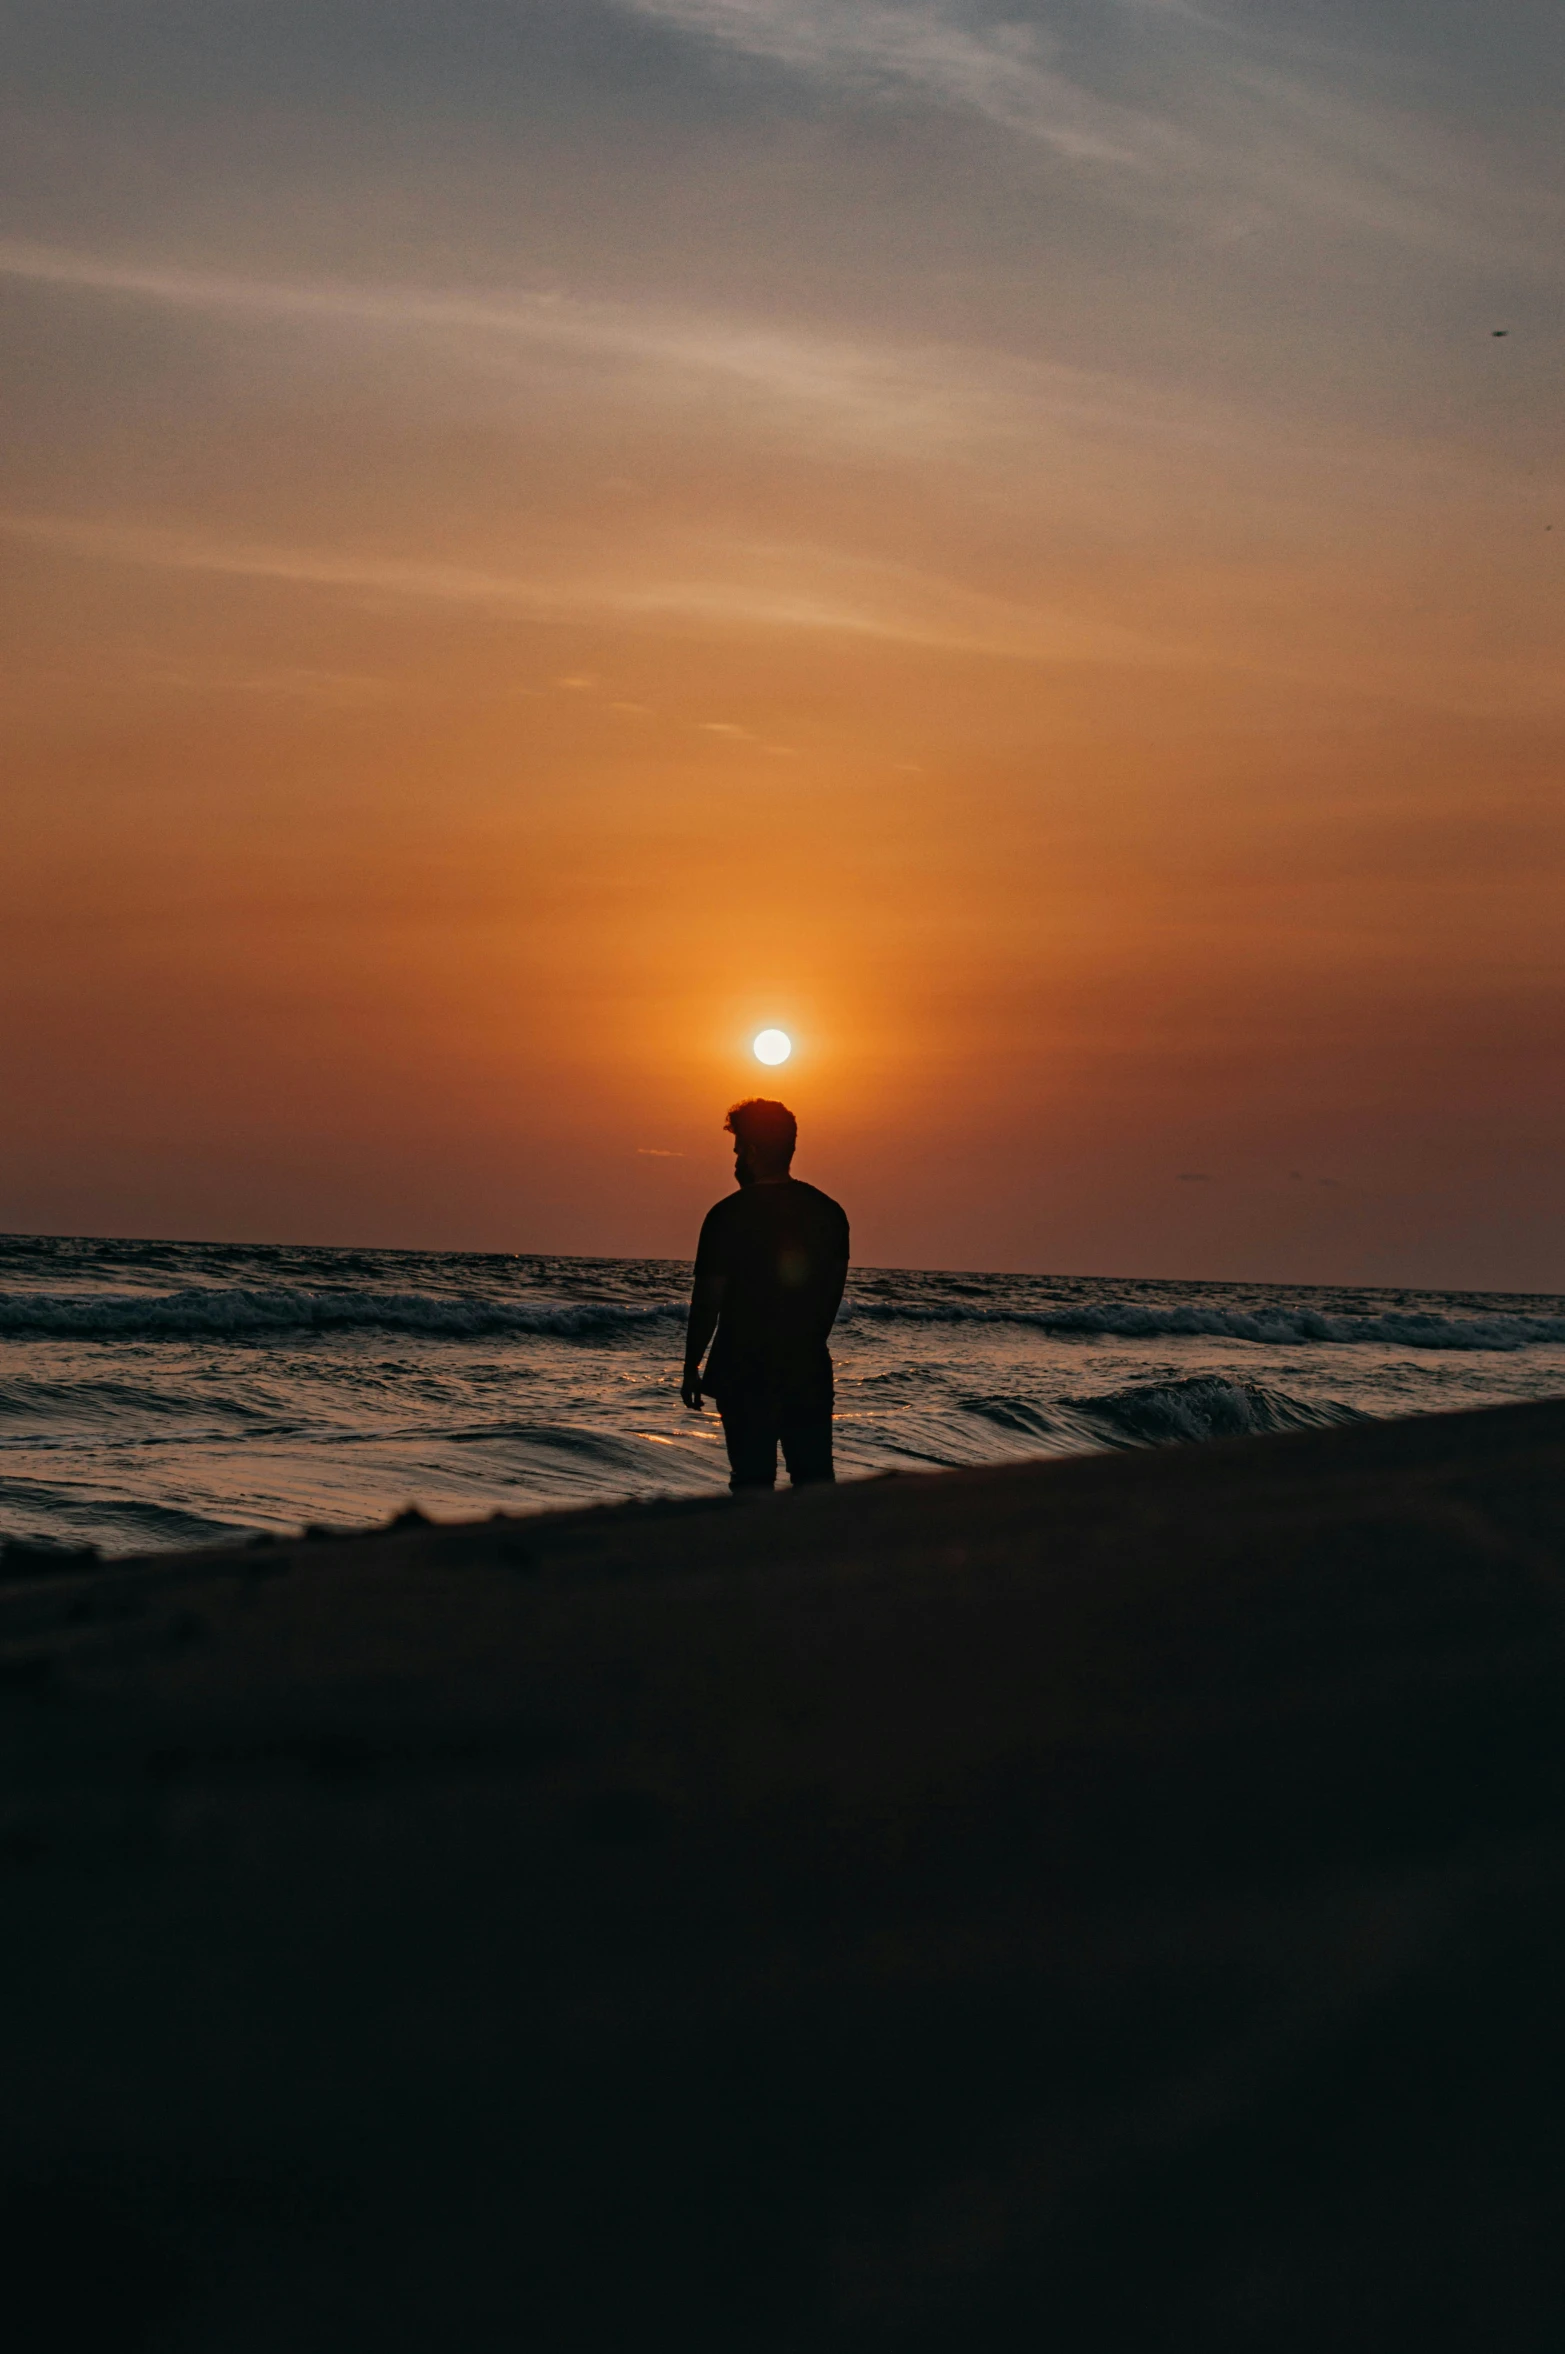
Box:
[0,1405,1565,2354]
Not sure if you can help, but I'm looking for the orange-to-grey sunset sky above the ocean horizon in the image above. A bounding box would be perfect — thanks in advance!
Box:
[0,0,1565,1290]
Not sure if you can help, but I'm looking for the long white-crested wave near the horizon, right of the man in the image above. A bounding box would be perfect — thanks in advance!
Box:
[845,1299,1565,1349]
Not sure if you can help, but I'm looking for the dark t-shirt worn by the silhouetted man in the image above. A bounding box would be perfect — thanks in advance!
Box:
[697,1177,847,1401]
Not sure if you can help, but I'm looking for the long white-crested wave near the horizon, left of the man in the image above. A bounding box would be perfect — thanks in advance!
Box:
[0,1285,685,1339]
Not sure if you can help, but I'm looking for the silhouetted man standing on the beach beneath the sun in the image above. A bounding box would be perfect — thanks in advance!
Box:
[680,1097,847,1488]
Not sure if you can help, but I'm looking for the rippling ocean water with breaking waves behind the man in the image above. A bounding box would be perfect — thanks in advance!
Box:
[0,1236,1565,1554]
